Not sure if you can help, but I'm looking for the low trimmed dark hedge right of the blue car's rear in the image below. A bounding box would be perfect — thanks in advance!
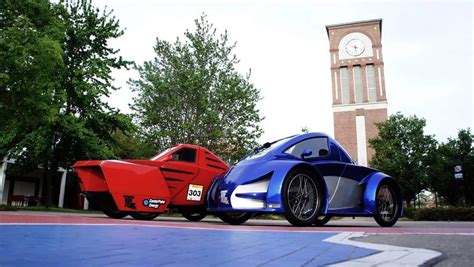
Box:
[404,207,474,221]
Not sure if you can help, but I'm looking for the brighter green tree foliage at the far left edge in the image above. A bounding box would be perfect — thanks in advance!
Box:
[0,0,65,168]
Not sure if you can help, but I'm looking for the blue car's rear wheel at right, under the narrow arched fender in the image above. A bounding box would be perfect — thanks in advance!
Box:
[374,181,400,227]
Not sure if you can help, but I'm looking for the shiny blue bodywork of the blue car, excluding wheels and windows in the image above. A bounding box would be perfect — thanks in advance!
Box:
[208,133,402,221]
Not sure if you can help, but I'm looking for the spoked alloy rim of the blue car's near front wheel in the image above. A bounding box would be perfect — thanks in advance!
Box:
[287,174,319,220]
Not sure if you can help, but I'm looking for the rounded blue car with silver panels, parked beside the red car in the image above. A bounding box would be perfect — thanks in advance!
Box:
[207,133,402,227]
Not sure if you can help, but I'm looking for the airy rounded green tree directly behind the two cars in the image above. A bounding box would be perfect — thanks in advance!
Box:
[130,15,262,161]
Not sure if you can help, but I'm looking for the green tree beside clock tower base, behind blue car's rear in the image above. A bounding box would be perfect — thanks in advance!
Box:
[369,113,436,205]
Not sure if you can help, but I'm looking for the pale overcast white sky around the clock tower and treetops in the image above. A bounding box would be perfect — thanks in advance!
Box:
[93,0,474,142]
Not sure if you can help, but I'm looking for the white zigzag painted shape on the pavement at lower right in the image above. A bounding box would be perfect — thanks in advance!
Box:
[323,232,441,266]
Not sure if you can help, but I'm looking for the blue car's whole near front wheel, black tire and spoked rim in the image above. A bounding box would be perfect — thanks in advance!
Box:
[281,168,323,226]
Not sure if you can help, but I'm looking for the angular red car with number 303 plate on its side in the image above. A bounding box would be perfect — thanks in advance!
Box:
[73,144,228,221]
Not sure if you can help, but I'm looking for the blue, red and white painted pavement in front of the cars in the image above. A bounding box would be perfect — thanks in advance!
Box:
[0,212,474,266]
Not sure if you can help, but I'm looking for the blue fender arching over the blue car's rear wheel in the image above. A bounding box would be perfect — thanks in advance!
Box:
[360,172,403,216]
